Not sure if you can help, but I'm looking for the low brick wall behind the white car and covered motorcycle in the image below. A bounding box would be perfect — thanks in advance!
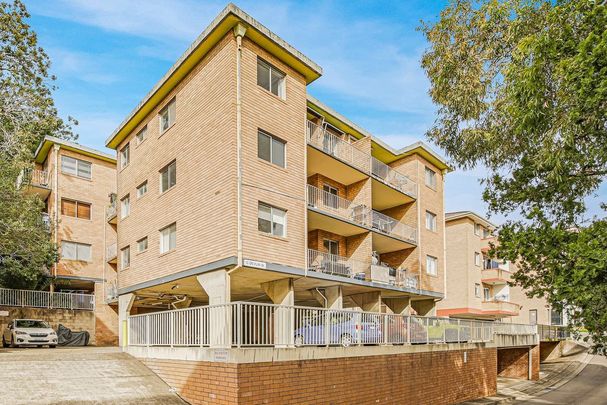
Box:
[0,306,96,344]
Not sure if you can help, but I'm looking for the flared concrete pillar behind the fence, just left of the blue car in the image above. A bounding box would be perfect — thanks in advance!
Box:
[261,278,295,347]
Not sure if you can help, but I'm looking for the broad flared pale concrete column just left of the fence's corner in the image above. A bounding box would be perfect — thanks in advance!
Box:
[196,270,232,348]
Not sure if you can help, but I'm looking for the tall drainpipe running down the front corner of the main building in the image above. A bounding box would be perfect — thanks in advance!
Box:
[234,24,247,267]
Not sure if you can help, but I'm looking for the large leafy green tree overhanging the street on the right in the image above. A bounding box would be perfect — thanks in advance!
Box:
[421,0,607,345]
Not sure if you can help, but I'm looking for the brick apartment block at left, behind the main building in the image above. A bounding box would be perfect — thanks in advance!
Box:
[18,136,118,345]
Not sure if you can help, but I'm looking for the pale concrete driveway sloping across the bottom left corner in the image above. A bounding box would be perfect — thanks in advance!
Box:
[0,347,186,405]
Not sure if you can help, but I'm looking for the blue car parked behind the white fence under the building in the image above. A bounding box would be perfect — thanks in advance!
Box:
[295,312,382,347]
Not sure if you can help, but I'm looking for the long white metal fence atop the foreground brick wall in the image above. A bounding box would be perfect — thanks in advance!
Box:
[128,302,494,347]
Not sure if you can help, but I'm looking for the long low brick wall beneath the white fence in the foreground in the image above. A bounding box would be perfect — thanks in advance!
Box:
[144,348,497,404]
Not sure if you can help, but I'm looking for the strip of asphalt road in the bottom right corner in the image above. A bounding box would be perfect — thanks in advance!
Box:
[513,355,607,405]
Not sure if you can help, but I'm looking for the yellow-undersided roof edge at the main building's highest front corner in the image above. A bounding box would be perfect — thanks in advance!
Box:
[106,3,322,149]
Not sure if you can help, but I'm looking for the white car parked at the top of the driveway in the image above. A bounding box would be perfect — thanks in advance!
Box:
[2,319,57,348]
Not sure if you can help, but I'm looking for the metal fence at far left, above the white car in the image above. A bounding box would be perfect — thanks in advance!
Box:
[0,288,95,311]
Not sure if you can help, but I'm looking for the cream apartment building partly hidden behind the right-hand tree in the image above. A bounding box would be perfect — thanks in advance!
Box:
[437,211,566,325]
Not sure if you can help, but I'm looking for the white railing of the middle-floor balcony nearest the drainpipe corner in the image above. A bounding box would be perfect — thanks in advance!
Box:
[307,184,370,227]
